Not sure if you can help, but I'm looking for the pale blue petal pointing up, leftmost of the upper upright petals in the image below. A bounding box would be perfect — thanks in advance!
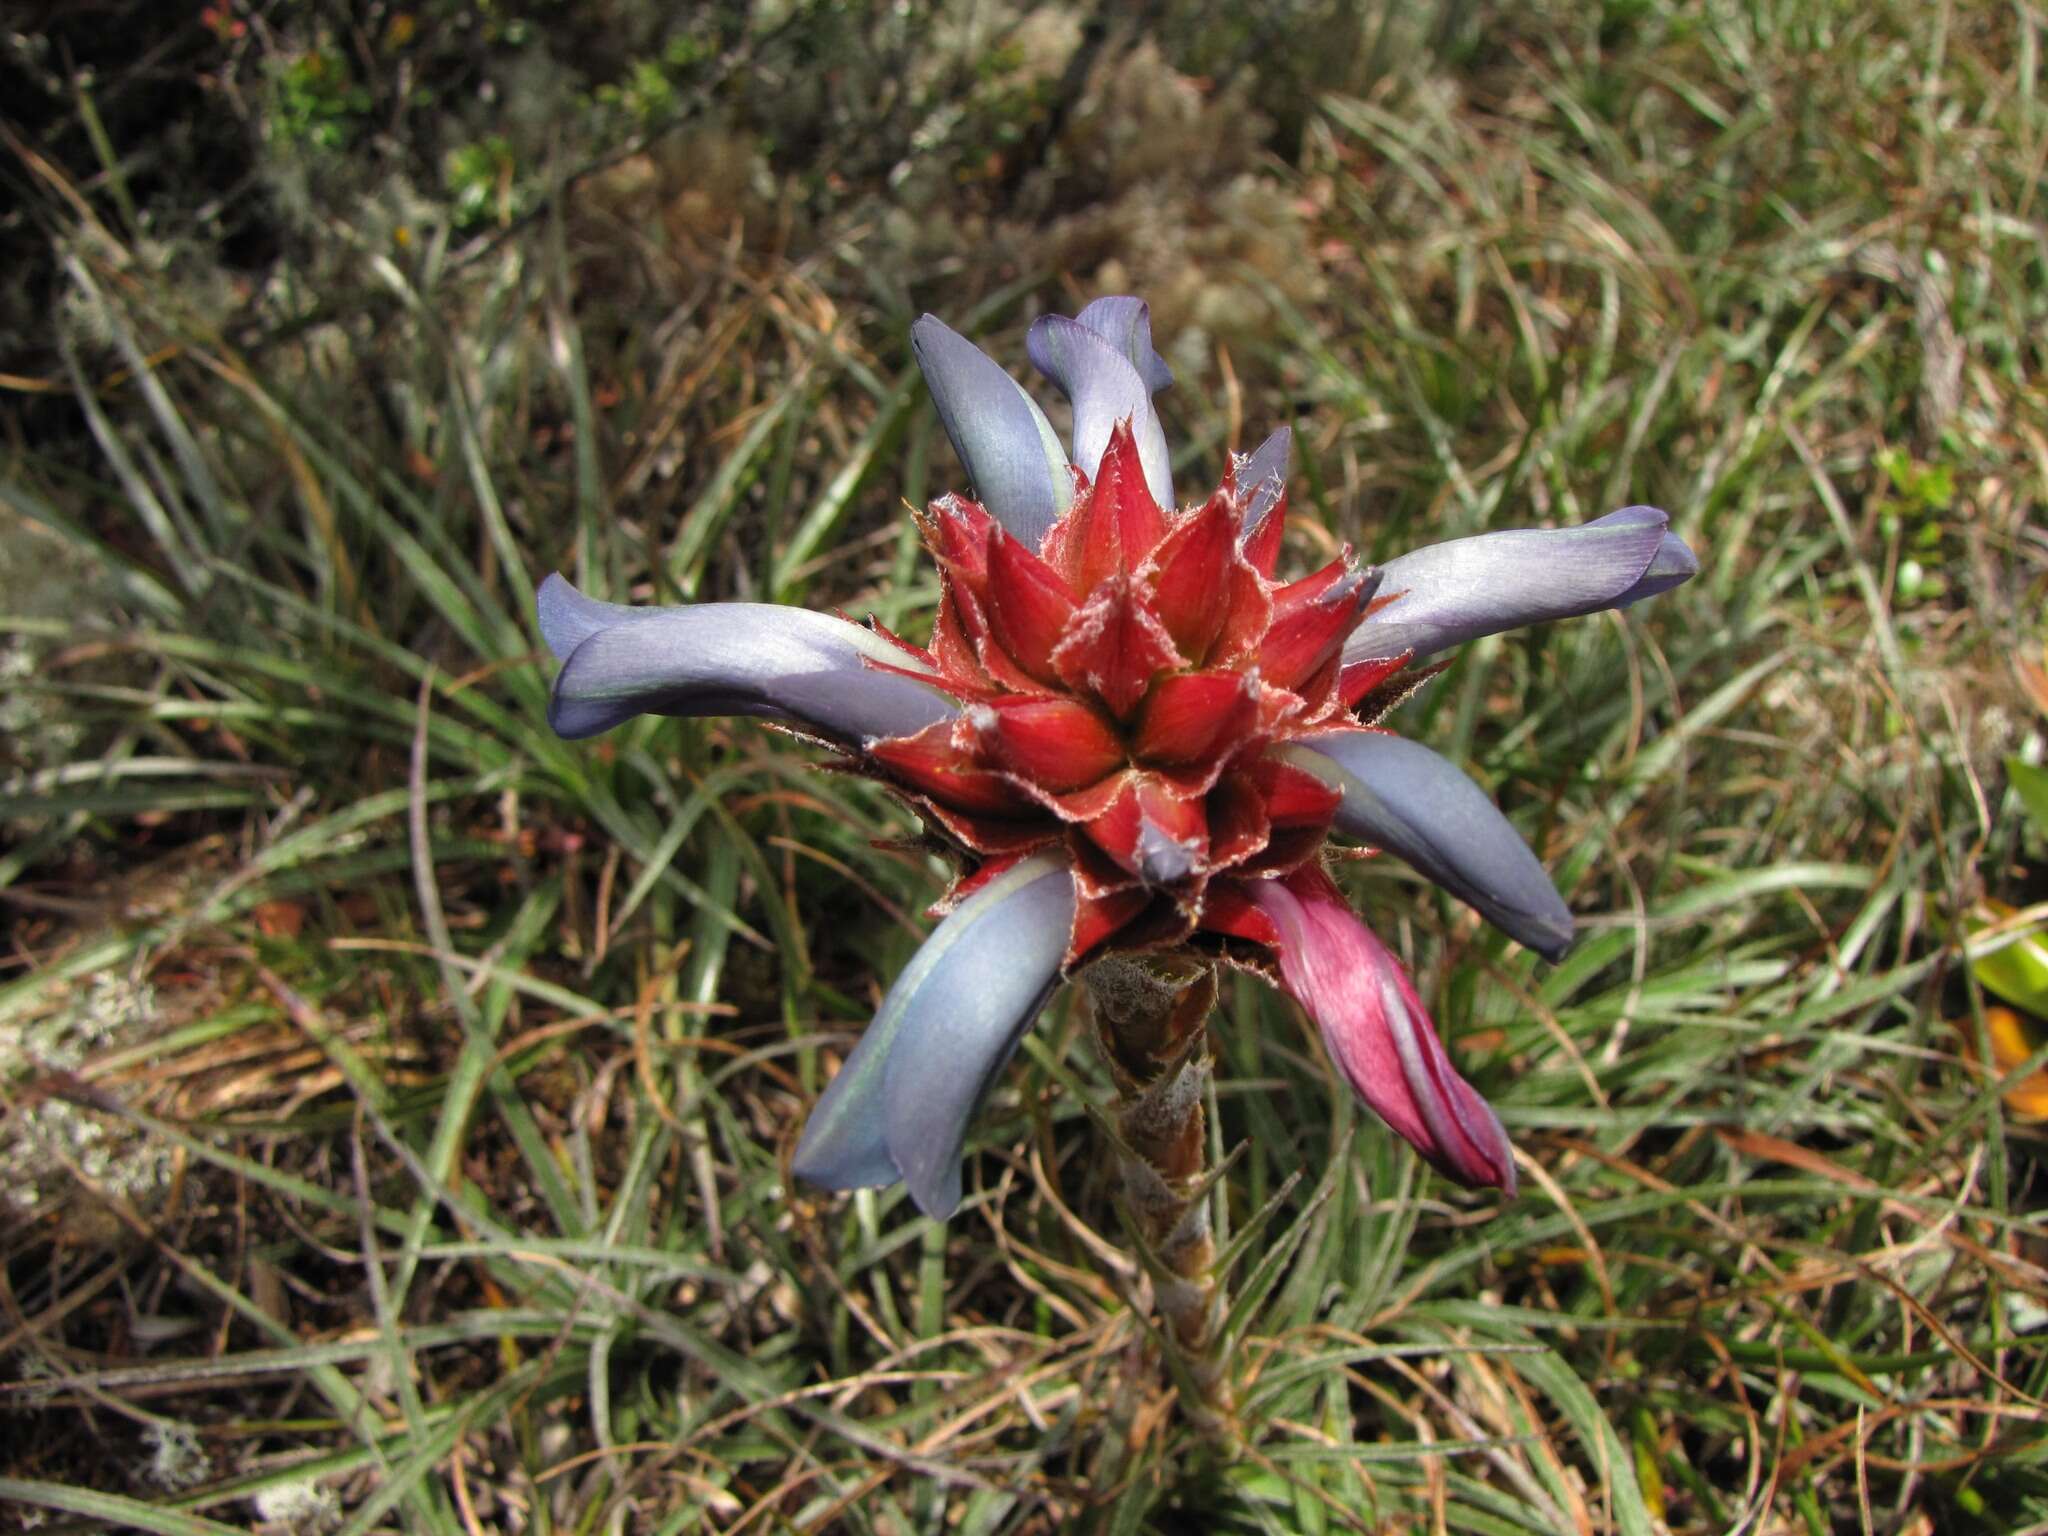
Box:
[909,315,1073,549]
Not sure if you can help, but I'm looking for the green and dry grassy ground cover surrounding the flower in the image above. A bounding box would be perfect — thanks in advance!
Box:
[0,0,2048,1536]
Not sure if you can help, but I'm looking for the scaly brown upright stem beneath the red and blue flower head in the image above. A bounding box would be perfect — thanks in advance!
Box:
[1083,958,1229,1415]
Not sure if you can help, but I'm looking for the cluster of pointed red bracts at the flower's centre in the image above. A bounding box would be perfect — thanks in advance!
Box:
[868,422,1399,969]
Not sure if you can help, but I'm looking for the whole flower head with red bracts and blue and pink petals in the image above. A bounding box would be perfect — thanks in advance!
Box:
[541,299,1698,1217]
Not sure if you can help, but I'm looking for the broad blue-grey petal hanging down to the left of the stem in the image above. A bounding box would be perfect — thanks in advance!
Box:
[793,854,1073,1221]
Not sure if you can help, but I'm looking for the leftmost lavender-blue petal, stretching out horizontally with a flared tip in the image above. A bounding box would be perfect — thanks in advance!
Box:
[539,575,954,743]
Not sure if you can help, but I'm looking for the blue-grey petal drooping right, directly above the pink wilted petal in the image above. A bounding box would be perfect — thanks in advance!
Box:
[1280,731,1571,961]
